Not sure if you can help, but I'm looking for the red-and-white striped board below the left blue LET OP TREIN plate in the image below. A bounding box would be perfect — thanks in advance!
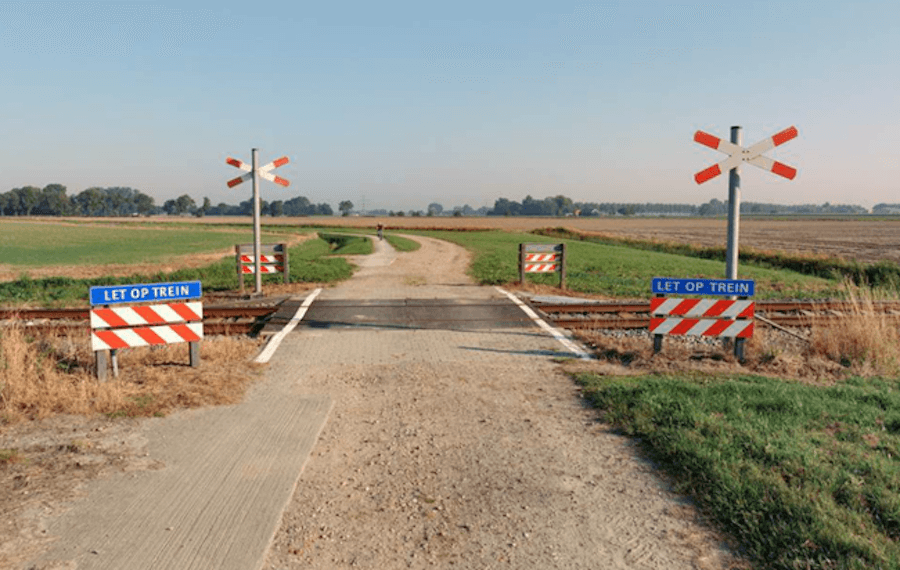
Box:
[91,302,203,351]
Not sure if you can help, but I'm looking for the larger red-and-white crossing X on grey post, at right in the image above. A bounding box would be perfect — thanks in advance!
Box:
[694,127,798,279]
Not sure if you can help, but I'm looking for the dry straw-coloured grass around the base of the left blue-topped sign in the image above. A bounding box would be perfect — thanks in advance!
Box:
[0,322,259,426]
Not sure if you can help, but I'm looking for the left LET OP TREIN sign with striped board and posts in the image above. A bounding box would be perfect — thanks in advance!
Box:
[90,281,203,381]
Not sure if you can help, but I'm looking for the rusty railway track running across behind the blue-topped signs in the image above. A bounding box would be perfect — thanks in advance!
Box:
[0,299,900,335]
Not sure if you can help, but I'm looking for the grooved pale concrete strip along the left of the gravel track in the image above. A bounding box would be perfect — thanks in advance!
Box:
[37,382,332,570]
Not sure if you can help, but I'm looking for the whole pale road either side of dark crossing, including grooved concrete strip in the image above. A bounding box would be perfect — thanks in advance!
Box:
[14,232,744,570]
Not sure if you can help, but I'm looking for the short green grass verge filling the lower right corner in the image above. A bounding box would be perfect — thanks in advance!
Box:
[576,374,900,570]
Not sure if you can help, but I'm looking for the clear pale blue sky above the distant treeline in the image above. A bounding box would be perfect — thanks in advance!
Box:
[0,0,900,210]
